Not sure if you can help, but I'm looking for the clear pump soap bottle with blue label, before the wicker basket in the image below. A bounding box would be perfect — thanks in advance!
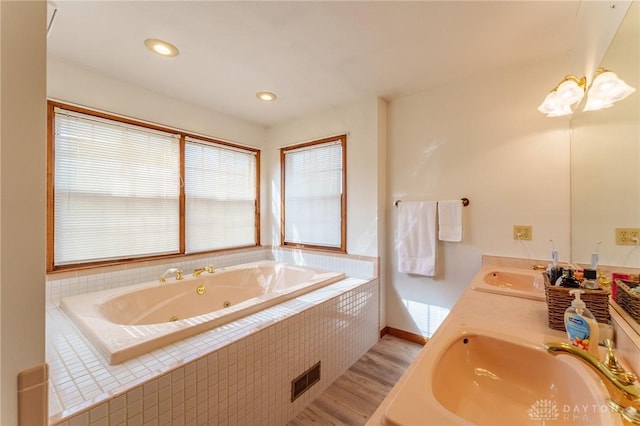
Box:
[564,290,598,357]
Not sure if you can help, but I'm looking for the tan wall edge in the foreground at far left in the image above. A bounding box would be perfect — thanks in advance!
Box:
[0,1,47,425]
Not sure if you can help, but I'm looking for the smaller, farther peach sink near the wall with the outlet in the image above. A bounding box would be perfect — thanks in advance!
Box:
[472,268,545,300]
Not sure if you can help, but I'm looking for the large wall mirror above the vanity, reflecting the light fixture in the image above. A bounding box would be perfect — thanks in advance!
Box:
[570,1,640,268]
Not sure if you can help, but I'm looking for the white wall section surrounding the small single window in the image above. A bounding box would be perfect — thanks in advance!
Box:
[262,98,385,256]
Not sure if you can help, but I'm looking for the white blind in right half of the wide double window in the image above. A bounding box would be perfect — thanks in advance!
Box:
[185,138,257,253]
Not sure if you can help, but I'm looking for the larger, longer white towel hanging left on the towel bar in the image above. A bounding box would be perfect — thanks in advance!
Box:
[397,201,437,277]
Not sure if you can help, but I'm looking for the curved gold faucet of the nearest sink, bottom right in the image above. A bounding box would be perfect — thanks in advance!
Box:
[544,339,640,425]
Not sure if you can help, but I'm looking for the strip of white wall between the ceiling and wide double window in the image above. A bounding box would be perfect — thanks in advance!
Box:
[47,55,265,148]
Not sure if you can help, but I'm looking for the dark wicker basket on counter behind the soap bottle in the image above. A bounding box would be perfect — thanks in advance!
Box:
[544,280,611,331]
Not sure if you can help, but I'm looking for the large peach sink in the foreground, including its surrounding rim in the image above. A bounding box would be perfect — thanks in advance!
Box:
[385,332,616,426]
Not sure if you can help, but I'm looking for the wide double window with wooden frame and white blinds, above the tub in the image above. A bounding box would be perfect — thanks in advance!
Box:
[47,102,259,271]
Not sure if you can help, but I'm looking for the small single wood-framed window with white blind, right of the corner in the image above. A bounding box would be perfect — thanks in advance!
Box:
[280,135,347,252]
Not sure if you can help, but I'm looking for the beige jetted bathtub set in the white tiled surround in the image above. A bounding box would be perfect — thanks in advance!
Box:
[60,261,345,365]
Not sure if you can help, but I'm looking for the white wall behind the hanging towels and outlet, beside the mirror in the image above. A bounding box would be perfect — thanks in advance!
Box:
[386,58,570,335]
